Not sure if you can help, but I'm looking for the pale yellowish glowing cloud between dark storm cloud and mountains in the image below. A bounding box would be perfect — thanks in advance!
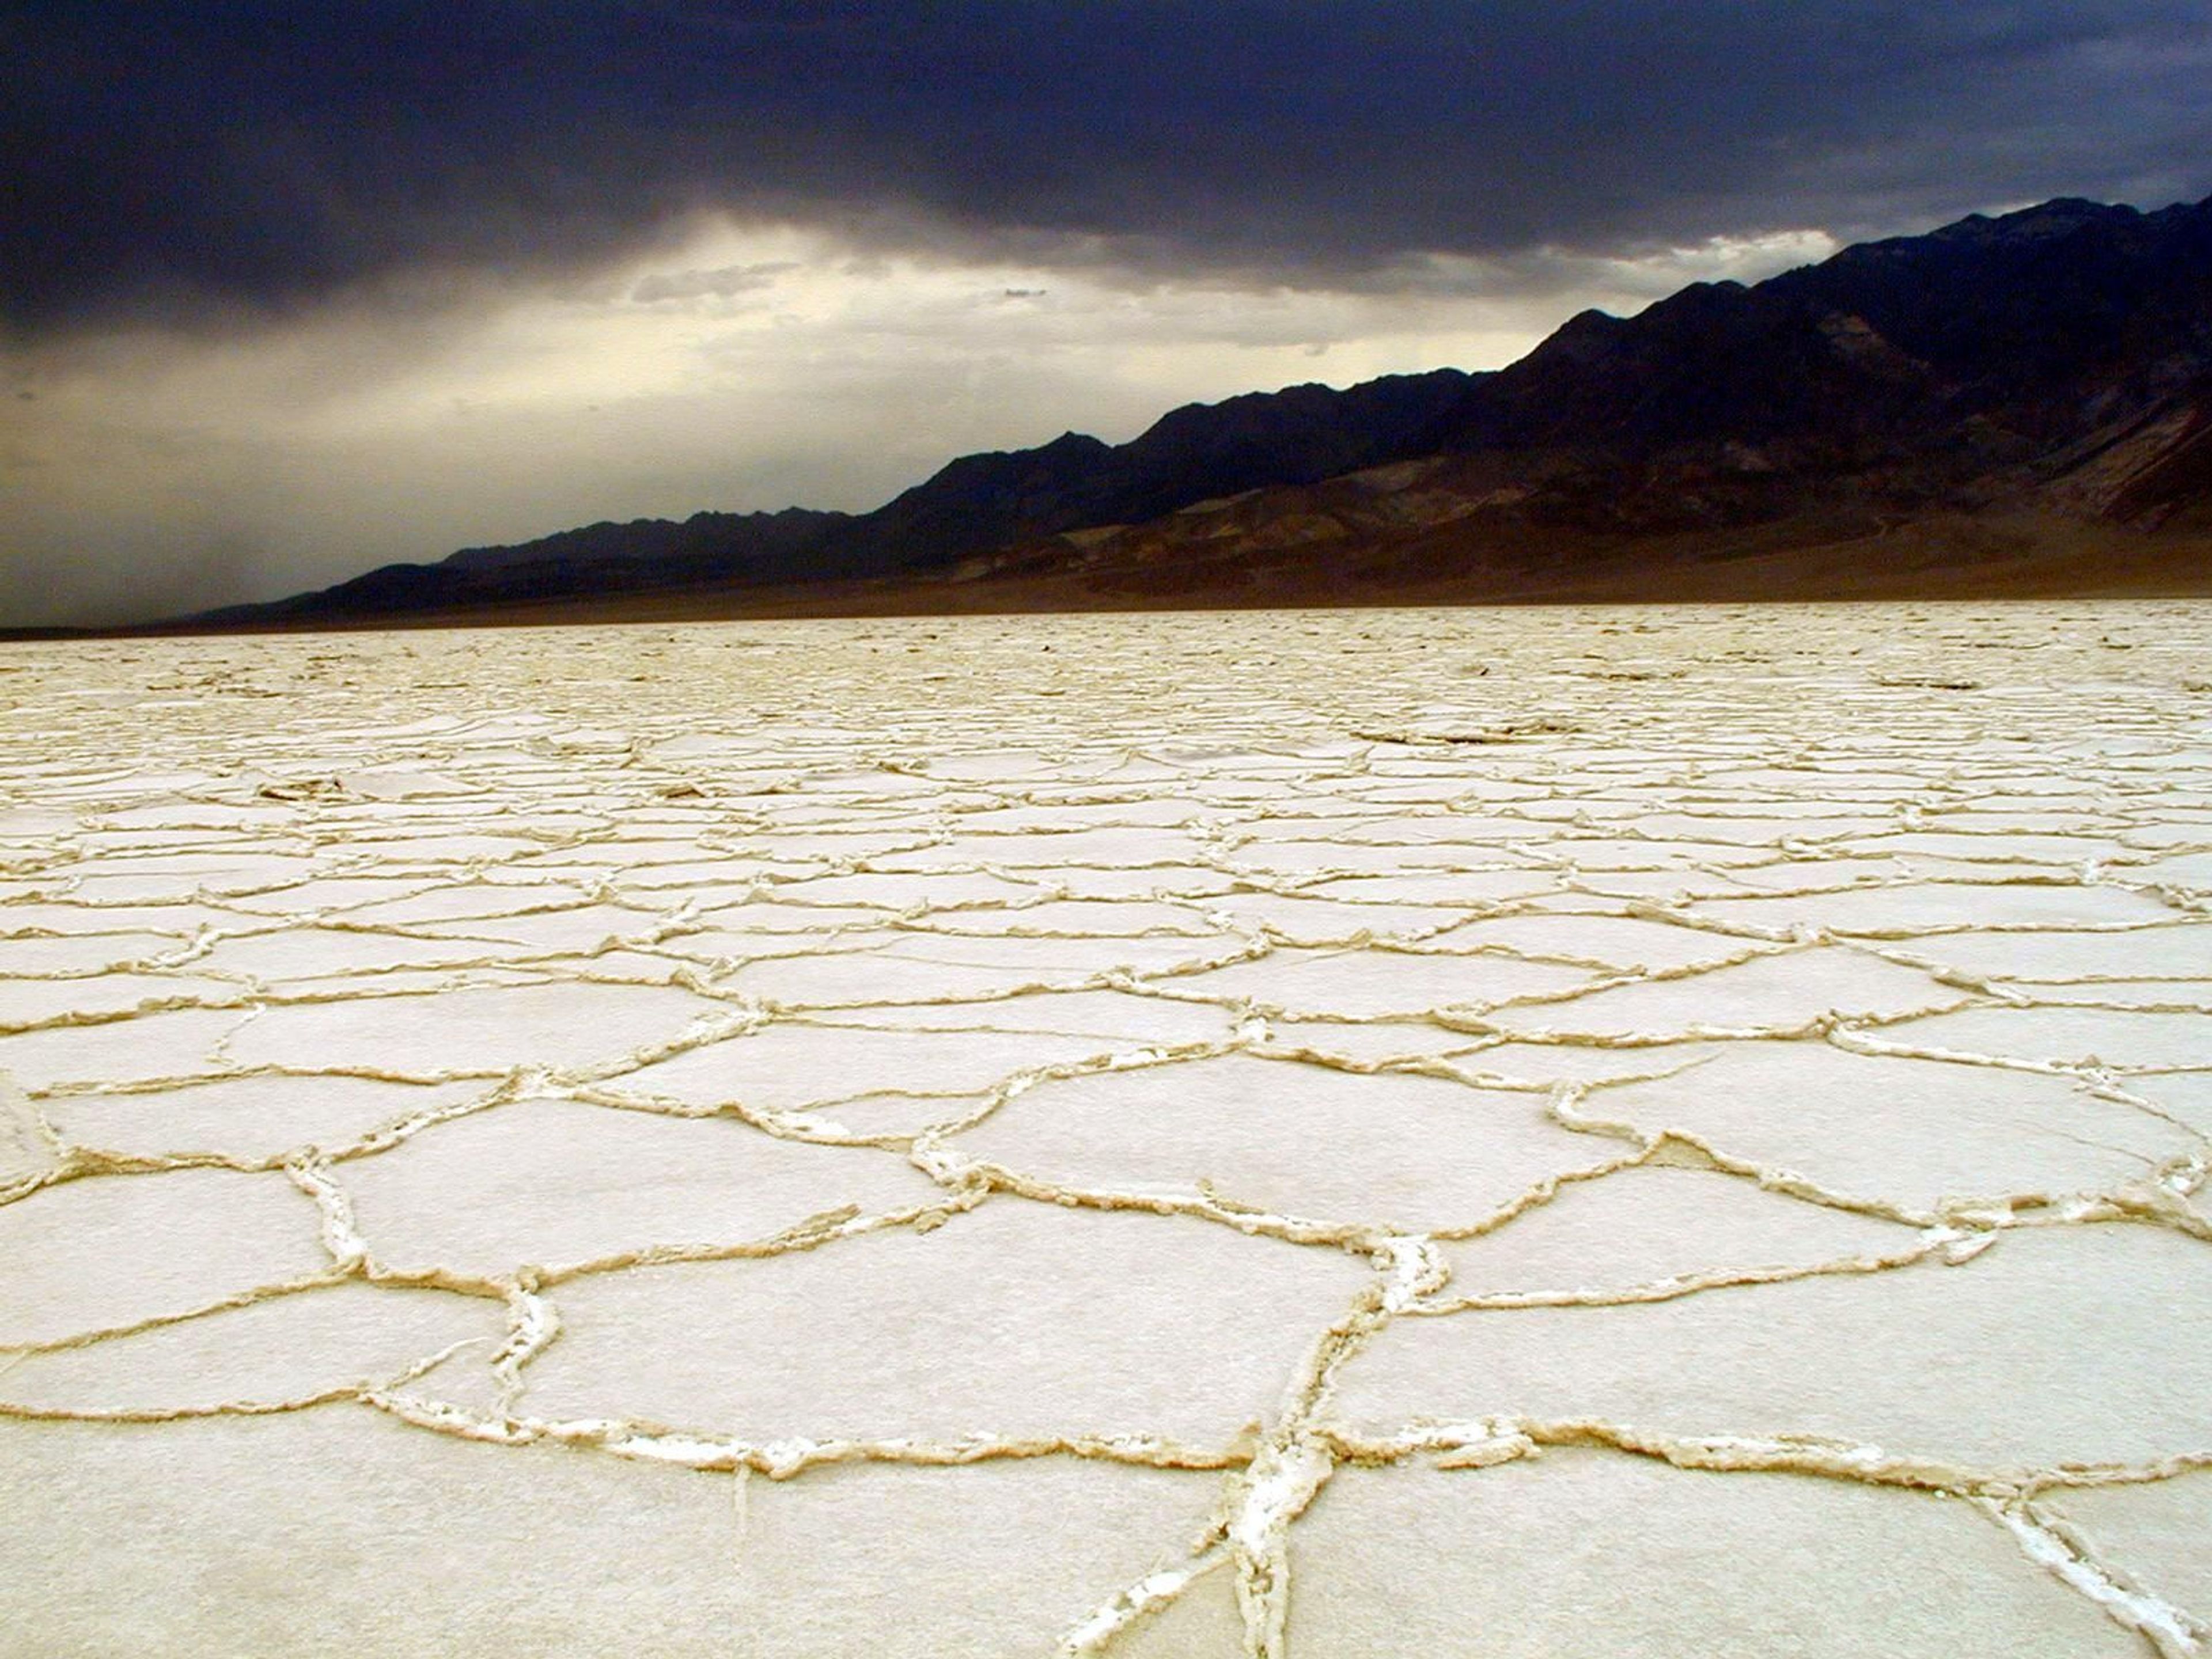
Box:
[0,219,1884,619]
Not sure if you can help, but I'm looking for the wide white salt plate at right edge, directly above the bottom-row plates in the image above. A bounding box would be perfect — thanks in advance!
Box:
[1336,1230,2212,1469]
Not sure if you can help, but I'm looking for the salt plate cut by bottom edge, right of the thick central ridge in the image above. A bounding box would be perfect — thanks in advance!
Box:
[1292,1451,2143,1659]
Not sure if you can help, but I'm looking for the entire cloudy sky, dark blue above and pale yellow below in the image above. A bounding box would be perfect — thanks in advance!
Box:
[0,0,2212,624]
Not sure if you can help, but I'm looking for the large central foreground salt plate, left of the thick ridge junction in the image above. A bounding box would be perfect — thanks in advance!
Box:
[531,1201,1367,1446]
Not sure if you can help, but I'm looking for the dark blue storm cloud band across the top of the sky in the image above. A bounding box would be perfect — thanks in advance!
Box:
[0,0,2212,334]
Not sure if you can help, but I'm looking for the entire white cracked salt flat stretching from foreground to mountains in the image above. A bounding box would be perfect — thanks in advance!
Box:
[0,601,2212,1659]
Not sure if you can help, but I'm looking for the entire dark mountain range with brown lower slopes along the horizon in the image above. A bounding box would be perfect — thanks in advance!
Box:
[186,199,2212,628]
